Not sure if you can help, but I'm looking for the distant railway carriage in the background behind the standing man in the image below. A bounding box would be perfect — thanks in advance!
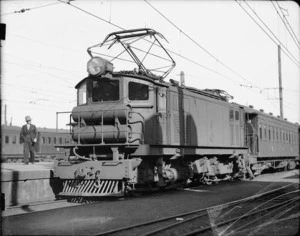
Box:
[1,125,71,161]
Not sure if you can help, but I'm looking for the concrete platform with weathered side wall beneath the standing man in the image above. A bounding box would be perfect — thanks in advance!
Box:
[1,162,61,207]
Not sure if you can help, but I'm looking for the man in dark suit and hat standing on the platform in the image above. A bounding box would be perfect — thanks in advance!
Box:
[20,116,37,165]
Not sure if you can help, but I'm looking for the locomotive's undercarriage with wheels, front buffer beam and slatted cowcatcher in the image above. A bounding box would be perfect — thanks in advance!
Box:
[54,145,253,197]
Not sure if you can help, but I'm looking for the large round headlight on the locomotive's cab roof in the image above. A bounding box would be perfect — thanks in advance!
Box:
[87,57,113,76]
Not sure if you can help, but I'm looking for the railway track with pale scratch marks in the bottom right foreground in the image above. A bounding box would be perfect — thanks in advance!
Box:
[94,184,299,236]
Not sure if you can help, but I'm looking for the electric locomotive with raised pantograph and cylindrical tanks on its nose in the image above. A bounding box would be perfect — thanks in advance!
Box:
[54,28,299,197]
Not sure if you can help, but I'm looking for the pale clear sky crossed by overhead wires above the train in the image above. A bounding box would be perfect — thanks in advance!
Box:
[1,0,300,128]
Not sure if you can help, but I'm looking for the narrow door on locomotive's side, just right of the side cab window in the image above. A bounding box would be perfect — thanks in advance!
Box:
[156,87,168,144]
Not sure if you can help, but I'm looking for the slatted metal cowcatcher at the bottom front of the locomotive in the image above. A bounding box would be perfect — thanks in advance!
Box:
[58,179,124,197]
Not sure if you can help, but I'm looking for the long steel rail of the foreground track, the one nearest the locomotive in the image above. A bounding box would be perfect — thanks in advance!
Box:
[93,183,295,236]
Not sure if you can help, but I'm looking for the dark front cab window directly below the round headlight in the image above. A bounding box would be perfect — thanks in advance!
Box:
[92,79,120,102]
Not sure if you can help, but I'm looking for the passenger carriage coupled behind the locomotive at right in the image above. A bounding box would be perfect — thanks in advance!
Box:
[244,107,299,173]
